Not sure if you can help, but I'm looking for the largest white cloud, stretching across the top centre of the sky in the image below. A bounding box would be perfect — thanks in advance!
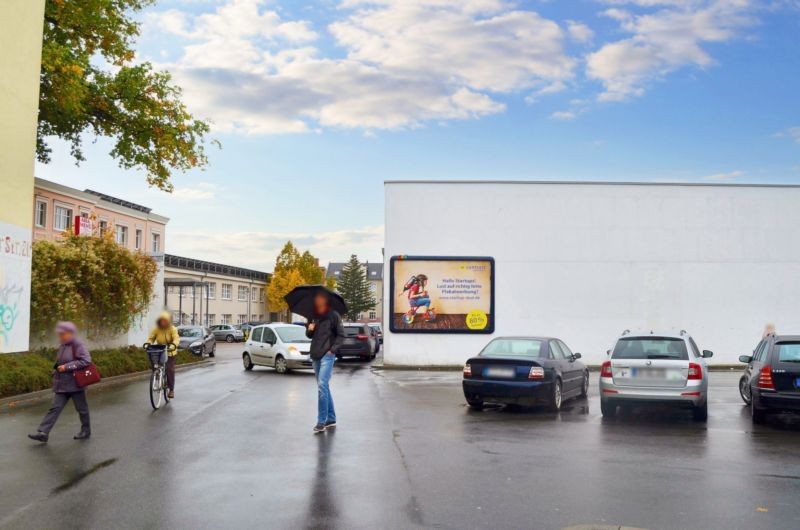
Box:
[147,0,576,134]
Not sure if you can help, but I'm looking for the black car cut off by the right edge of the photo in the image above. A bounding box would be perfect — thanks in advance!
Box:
[739,334,800,423]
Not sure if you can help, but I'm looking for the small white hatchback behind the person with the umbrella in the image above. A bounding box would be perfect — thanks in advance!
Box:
[242,324,312,374]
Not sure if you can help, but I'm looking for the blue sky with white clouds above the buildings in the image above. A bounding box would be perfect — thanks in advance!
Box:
[36,0,800,271]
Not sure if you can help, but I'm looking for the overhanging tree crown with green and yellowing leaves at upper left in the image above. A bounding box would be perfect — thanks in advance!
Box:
[36,0,214,191]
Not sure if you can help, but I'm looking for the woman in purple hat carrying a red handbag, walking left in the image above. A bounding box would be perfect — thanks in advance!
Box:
[28,322,92,443]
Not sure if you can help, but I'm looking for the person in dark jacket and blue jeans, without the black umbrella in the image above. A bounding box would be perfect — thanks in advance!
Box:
[306,293,344,434]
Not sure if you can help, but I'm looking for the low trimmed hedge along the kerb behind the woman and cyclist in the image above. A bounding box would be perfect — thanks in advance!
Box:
[0,346,201,398]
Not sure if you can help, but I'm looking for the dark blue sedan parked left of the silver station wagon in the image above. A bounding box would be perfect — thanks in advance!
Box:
[463,337,589,411]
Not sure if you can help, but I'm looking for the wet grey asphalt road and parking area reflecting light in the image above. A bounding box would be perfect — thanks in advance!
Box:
[0,345,800,529]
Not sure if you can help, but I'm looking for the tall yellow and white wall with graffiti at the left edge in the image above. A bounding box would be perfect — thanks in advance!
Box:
[0,0,44,353]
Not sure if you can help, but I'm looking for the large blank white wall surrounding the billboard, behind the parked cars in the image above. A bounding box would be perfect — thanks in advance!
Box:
[384,182,800,365]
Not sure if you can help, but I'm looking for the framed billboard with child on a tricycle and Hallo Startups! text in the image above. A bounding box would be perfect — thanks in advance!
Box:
[389,256,495,333]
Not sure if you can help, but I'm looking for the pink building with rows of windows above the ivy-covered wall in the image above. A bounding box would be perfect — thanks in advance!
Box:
[33,178,169,255]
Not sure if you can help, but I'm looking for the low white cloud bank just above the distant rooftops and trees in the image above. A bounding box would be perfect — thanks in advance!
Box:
[167,226,383,272]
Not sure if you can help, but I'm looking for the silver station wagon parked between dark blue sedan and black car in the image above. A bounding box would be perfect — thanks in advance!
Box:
[600,331,714,421]
